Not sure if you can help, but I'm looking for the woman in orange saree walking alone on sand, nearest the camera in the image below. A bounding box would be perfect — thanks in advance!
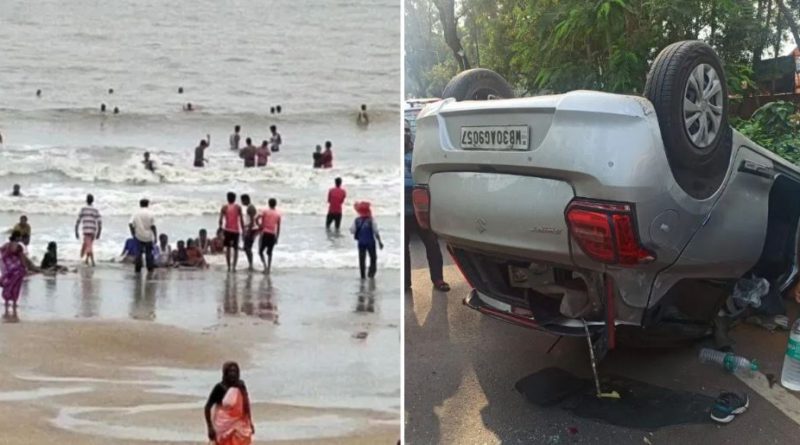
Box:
[205,362,255,445]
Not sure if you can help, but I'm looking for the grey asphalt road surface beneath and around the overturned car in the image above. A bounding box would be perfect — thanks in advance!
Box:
[405,241,800,445]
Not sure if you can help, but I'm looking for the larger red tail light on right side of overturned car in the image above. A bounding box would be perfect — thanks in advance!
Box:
[567,199,655,266]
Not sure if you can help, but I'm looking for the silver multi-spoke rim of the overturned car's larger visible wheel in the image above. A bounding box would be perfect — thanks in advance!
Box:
[683,63,724,148]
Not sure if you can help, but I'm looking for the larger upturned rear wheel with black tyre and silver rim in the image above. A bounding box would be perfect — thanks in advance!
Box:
[644,40,732,199]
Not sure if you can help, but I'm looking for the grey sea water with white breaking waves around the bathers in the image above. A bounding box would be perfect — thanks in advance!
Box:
[0,0,402,268]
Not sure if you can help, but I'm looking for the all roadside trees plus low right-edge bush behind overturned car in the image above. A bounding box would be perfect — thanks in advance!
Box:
[405,0,800,164]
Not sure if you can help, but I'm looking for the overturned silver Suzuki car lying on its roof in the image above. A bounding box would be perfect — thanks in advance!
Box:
[413,41,800,354]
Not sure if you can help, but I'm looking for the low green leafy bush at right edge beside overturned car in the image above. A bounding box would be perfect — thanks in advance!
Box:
[733,101,800,165]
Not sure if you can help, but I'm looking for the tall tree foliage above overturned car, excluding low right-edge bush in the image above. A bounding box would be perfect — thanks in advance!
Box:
[405,0,800,96]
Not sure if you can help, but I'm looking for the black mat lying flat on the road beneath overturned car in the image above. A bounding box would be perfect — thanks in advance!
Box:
[516,368,714,430]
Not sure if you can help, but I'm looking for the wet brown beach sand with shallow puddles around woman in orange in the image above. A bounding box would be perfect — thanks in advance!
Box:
[0,268,400,445]
